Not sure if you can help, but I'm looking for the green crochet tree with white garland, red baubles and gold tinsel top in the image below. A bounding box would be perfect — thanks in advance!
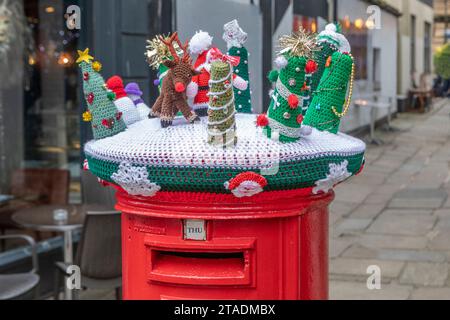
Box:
[258,31,317,142]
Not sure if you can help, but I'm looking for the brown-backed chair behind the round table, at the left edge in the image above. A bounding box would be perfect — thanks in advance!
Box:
[0,169,70,250]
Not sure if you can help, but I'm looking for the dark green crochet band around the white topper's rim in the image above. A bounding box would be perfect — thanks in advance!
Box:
[87,153,364,194]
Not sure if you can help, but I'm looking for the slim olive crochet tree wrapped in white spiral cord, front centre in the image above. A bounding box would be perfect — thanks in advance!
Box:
[208,60,237,148]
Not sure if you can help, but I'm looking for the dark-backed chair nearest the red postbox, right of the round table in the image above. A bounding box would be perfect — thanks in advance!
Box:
[54,211,122,300]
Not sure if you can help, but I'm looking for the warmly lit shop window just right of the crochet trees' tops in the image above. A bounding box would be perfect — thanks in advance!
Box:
[340,17,368,80]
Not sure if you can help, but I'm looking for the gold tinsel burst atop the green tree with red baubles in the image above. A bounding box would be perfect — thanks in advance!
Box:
[279,28,320,59]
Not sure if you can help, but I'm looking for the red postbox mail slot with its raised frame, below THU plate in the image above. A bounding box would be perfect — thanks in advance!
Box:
[146,236,255,286]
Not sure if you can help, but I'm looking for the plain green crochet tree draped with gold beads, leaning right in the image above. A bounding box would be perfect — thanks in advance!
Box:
[304,52,355,133]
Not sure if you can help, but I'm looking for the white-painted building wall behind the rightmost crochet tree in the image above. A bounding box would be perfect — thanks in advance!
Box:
[338,0,398,132]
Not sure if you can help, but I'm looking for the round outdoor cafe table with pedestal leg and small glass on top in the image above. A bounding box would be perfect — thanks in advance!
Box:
[12,205,104,300]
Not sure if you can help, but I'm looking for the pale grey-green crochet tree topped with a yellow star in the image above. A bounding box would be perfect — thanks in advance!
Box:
[77,49,126,140]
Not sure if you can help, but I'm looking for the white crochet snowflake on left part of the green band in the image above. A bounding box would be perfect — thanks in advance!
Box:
[111,162,161,197]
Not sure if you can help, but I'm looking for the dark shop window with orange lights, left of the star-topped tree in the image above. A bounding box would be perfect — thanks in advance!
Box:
[23,0,80,202]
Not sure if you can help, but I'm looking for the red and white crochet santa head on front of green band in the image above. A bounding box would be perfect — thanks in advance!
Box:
[224,172,267,198]
